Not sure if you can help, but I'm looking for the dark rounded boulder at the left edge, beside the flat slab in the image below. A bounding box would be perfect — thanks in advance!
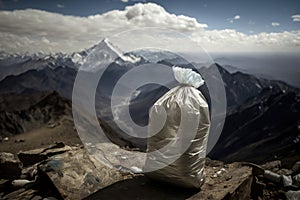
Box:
[0,152,22,179]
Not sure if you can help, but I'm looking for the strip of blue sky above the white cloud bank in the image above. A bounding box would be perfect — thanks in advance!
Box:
[0,0,300,34]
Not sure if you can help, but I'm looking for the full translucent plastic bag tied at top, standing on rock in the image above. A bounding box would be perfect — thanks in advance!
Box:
[145,67,210,188]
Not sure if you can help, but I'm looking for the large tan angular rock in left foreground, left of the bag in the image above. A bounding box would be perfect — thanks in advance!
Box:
[38,147,124,199]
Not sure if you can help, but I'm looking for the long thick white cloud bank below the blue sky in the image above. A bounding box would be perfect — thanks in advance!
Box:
[0,3,300,53]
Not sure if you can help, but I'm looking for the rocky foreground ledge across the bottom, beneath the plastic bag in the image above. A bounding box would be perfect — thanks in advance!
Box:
[0,143,299,200]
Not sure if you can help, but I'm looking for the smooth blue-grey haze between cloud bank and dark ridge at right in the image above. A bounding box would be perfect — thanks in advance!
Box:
[211,53,300,88]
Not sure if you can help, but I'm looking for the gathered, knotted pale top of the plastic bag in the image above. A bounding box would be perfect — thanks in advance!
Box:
[172,66,204,88]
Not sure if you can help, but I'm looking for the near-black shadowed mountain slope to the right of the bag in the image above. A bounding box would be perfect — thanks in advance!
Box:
[209,88,300,164]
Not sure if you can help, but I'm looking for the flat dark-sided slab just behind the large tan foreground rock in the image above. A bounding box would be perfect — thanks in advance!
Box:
[18,142,71,166]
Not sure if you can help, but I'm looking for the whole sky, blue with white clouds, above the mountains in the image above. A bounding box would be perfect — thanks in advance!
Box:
[0,0,300,53]
